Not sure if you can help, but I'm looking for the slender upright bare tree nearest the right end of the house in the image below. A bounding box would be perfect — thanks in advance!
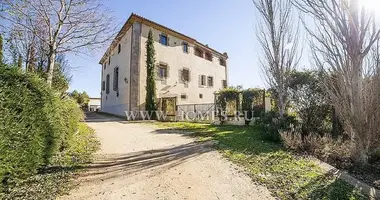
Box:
[253,0,300,117]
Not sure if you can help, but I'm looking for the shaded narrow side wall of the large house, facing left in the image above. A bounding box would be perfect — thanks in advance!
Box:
[101,29,132,116]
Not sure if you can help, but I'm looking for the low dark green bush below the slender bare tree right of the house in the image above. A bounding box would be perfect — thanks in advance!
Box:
[256,111,297,142]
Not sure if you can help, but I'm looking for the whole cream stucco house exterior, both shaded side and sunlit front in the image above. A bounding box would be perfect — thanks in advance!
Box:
[100,14,228,116]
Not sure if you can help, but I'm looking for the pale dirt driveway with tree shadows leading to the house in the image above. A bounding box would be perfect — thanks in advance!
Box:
[61,113,273,200]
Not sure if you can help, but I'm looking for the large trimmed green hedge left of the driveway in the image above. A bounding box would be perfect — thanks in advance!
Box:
[0,66,83,189]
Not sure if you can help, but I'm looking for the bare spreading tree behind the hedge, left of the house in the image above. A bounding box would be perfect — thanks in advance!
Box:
[0,0,116,85]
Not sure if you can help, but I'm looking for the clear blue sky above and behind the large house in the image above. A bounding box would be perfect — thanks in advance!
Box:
[68,0,266,97]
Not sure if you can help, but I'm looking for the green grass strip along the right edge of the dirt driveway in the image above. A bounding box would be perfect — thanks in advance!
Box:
[155,122,368,200]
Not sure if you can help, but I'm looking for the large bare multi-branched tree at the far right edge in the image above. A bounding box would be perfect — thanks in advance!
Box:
[294,0,380,164]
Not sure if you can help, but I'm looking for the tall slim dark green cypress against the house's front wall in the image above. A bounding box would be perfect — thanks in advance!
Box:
[145,30,157,118]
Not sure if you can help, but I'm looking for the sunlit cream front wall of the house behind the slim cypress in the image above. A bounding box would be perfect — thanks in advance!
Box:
[140,24,228,109]
